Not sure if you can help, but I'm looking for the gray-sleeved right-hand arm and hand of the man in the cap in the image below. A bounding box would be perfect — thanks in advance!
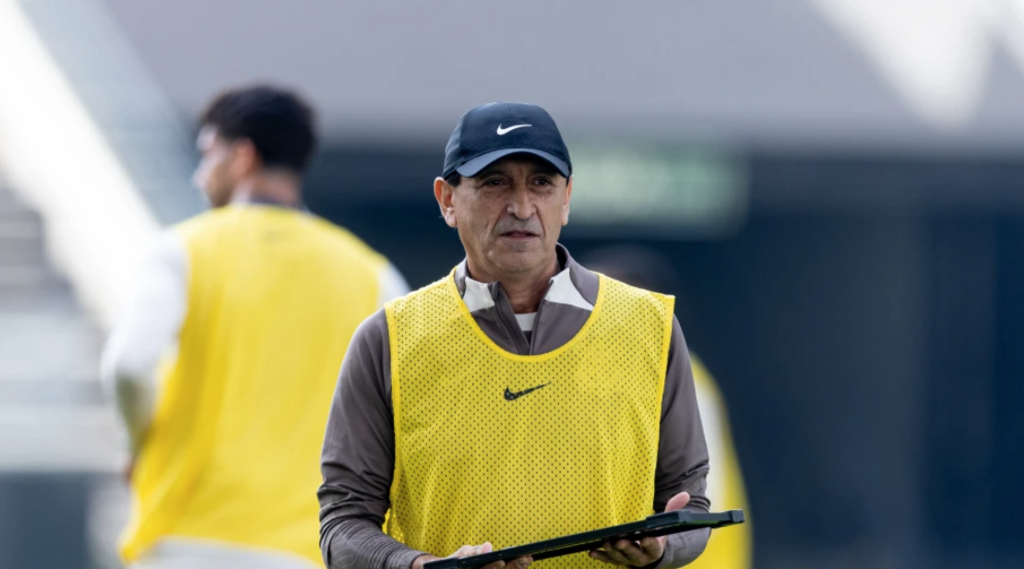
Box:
[592,318,711,569]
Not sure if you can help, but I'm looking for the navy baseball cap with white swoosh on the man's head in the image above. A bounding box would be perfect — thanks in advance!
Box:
[441,101,572,178]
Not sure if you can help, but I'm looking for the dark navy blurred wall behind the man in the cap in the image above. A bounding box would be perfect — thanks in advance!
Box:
[309,147,1024,568]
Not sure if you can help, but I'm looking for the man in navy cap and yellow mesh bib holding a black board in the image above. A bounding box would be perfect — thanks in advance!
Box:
[318,102,709,569]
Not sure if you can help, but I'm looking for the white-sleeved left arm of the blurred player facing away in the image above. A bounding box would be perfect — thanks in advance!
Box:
[100,231,187,458]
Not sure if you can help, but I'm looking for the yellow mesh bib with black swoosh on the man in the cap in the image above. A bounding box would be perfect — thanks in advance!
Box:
[385,276,675,568]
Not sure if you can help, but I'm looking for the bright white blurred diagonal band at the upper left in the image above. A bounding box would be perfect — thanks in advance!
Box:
[0,0,159,326]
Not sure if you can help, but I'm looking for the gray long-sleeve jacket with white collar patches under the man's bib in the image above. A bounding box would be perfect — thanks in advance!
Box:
[317,246,710,569]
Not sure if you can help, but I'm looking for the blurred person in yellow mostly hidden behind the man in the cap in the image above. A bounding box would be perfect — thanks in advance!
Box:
[583,247,753,569]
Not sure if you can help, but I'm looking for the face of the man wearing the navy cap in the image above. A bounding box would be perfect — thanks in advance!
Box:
[434,155,572,280]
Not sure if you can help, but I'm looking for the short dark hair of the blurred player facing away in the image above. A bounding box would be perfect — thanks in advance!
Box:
[200,85,316,174]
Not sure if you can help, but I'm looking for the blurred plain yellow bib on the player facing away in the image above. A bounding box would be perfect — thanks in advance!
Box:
[122,207,386,567]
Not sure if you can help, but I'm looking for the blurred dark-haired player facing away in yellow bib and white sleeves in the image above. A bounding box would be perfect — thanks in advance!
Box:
[103,87,407,569]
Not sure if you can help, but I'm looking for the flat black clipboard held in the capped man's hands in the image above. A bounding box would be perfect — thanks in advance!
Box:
[423,510,744,569]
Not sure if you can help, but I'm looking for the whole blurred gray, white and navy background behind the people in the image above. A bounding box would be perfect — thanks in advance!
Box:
[0,0,1024,569]
